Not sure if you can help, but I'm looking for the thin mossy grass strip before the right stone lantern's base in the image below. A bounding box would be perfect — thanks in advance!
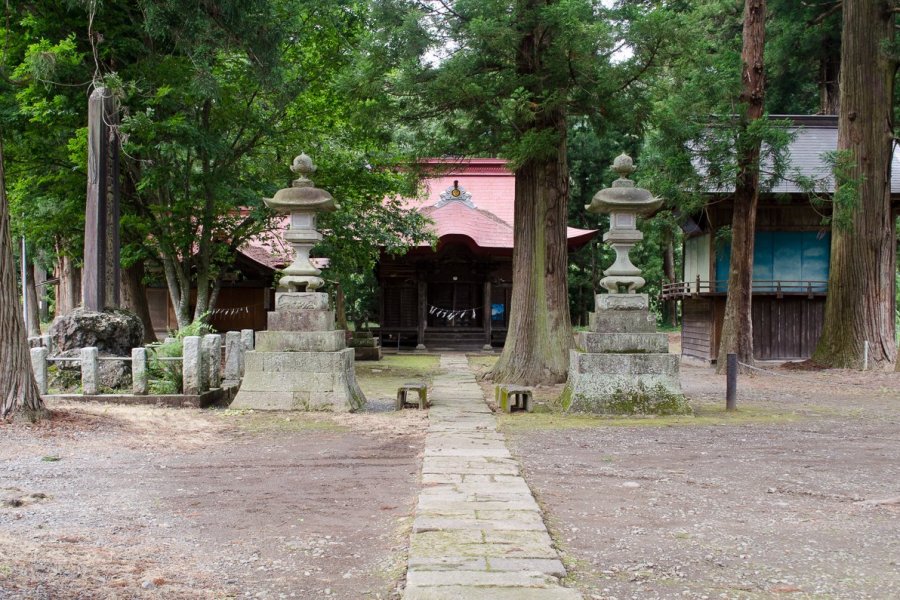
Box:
[498,406,807,432]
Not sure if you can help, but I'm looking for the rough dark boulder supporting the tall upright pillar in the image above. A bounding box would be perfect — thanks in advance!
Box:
[50,308,144,357]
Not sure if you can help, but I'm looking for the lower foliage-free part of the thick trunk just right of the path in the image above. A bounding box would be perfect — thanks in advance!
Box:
[493,145,573,385]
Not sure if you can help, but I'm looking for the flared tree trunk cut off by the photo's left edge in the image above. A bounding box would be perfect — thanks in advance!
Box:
[0,140,47,421]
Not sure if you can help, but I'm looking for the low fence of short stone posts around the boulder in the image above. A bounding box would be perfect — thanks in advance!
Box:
[31,329,255,406]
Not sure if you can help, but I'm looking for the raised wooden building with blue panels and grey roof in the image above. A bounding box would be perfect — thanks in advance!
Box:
[662,116,900,362]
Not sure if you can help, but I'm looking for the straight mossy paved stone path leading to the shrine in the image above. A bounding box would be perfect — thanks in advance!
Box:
[403,355,582,600]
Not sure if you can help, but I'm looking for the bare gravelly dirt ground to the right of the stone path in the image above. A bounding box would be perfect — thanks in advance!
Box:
[501,365,900,600]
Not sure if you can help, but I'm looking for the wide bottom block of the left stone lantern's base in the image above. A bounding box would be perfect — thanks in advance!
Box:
[231,346,366,412]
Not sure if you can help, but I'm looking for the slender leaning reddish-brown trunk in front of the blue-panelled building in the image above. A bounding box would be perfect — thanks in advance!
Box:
[716,0,766,373]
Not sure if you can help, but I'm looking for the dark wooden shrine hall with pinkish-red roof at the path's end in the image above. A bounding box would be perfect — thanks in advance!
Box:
[377,159,596,349]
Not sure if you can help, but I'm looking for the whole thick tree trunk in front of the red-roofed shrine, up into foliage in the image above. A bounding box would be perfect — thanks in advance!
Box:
[491,0,574,385]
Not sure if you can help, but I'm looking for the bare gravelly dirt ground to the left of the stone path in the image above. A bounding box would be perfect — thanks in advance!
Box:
[0,404,424,600]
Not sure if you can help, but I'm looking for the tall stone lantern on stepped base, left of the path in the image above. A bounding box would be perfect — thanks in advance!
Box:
[231,154,366,411]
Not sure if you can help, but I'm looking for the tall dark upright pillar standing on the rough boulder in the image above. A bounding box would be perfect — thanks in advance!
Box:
[82,87,120,311]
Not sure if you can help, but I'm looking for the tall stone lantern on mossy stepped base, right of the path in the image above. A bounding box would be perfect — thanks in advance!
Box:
[563,154,689,413]
